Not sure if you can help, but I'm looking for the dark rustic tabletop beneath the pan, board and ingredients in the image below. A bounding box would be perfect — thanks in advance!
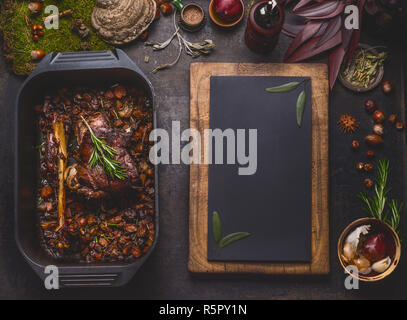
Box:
[0,0,407,299]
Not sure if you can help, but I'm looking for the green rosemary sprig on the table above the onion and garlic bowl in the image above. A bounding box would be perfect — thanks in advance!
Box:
[358,159,403,233]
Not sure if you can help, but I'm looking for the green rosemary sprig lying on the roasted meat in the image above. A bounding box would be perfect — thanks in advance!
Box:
[81,116,127,180]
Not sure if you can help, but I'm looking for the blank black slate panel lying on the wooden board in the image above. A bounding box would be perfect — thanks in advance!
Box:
[208,76,312,262]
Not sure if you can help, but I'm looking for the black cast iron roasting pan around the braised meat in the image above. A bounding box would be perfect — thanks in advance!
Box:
[14,49,159,287]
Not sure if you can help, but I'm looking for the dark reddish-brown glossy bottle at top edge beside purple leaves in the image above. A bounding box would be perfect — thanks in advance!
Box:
[245,0,284,53]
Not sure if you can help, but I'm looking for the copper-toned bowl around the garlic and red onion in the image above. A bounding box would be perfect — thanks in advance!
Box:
[337,218,401,282]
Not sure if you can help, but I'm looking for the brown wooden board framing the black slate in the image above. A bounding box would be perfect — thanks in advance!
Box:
[188,63,329,274]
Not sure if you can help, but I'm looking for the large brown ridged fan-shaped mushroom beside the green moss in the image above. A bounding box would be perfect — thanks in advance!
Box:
[91,0,156,45]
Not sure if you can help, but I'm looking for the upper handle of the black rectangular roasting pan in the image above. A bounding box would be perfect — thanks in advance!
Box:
[29,49,144,78]
